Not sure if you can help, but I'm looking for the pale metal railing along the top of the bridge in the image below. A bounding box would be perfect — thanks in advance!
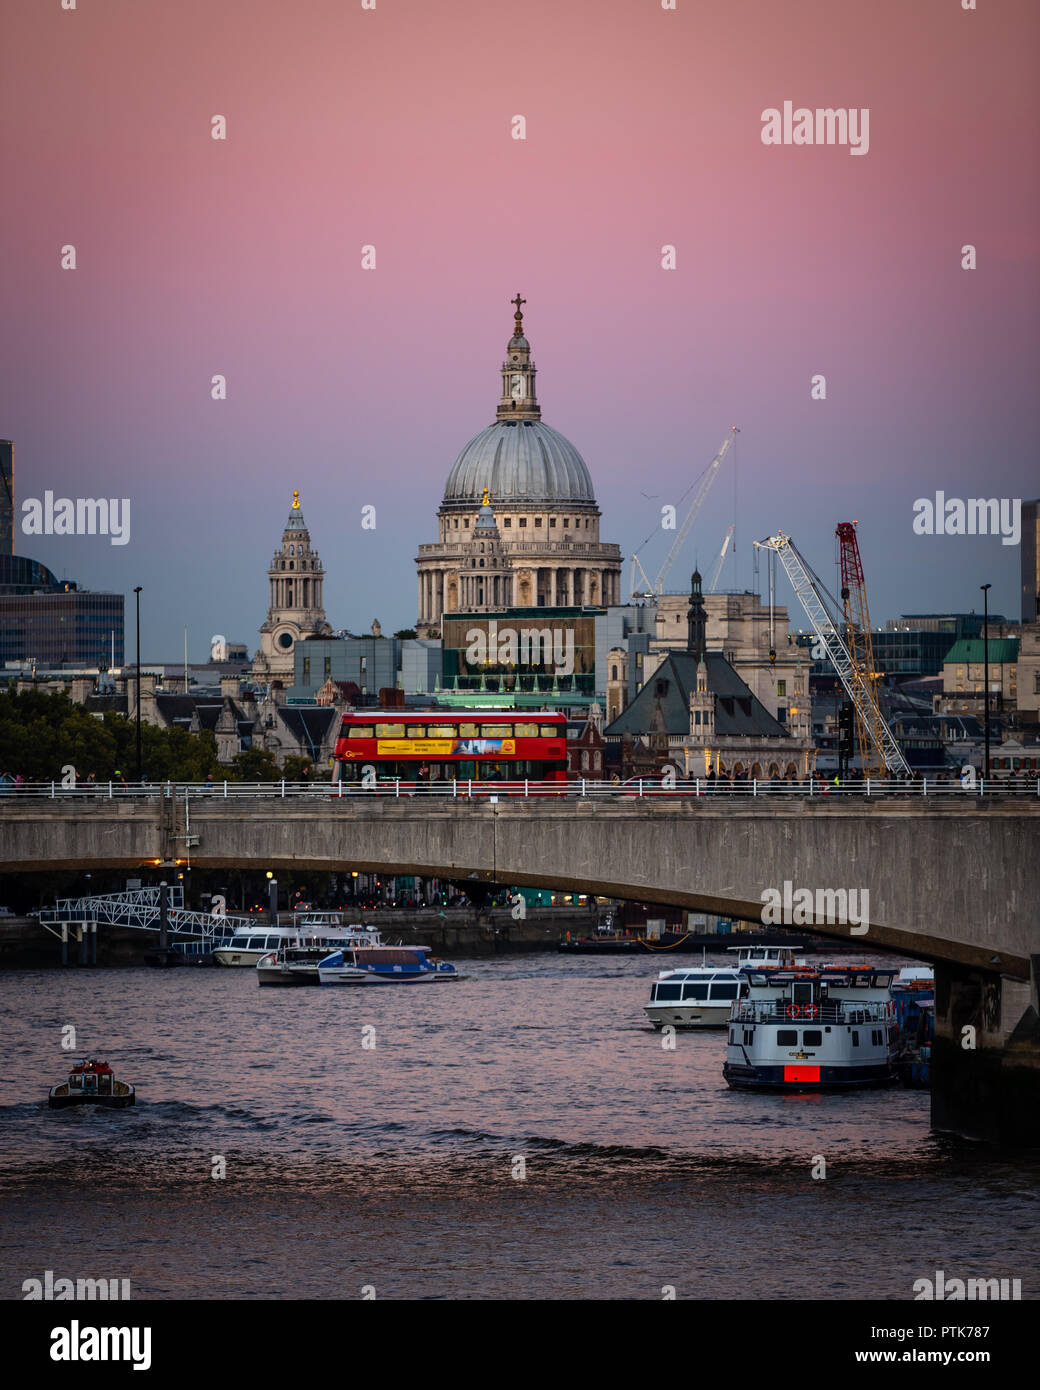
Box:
[0,773,1040,810]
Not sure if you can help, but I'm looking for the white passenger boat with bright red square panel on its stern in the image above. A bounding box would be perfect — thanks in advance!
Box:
[723,965,898,1091]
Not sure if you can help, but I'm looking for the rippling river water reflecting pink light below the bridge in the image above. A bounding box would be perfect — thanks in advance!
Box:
[0,955,1040,1298]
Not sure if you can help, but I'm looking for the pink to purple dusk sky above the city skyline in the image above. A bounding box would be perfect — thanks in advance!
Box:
[0,0,1040,662]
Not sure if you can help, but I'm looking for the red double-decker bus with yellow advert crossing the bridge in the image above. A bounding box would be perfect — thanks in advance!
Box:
[334,709,567,783]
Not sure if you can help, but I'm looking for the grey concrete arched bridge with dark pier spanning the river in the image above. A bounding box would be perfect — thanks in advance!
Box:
[0,787,1040,1144]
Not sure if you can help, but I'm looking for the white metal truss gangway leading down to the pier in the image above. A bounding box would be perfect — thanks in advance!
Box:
[33,884,256,965]
